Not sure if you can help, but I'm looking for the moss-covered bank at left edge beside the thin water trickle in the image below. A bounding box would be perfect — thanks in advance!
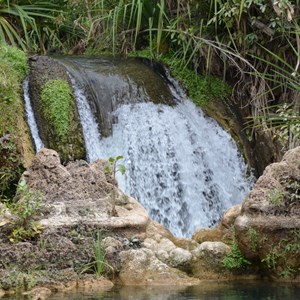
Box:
[0,44,28,197]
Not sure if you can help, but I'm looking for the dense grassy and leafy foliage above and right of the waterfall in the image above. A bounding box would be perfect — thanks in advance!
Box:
[0,0,300,148]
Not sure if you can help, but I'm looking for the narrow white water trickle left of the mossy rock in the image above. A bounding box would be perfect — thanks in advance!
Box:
[23,78,44,151]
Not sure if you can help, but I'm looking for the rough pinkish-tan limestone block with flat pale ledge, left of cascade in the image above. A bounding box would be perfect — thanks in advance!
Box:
[23,148,148,228]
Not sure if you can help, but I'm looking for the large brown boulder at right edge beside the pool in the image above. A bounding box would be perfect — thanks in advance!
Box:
[234,147,300,276]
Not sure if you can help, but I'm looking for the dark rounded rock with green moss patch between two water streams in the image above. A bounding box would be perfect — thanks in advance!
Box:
[29,56,85,162]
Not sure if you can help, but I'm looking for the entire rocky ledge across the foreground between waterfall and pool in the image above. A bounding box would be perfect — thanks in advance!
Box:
[0,147,300,294]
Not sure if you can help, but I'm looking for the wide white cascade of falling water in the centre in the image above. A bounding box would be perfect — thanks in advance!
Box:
[68,58,251,237]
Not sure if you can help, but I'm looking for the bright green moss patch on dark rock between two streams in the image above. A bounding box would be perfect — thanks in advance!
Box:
[41,80,73,141]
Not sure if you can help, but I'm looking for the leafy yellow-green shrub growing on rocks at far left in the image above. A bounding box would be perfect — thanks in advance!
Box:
[3,179,43,243]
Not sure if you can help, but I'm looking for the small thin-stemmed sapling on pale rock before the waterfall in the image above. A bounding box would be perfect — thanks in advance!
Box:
[104,155,126,217]
